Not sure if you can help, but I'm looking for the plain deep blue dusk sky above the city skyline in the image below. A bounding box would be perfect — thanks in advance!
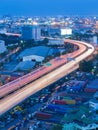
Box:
[0,0,98,16]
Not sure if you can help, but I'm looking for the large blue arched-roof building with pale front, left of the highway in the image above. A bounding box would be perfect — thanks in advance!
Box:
[18,46,54,62]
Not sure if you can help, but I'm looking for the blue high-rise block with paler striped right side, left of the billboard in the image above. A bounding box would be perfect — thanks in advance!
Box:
[22,25,41,40]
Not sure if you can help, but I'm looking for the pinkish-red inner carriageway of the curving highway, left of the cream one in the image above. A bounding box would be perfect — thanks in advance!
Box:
[0,40,86,98]
